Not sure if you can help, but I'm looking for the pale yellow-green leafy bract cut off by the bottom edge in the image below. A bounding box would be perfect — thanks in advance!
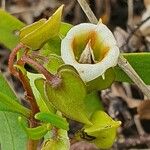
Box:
[42,129,70,150]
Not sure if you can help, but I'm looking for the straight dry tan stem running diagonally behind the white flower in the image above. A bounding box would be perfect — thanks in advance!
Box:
[77,0,150,99]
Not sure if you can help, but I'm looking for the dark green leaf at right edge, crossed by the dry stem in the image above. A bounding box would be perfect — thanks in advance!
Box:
[115,53,150,85]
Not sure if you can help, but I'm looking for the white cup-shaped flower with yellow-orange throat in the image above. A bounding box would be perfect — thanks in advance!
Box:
[61,21,119,82]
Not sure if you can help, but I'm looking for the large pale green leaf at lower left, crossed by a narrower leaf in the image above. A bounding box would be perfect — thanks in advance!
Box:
[0,73,27,150]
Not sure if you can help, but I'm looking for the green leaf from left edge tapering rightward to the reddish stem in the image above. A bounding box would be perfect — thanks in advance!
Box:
[0,92,30,118]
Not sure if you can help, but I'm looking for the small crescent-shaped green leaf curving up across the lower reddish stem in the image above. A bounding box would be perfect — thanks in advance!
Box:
[18,117,51,140]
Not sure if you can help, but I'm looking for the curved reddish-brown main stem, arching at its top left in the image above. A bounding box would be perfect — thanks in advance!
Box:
[8,44,39,150]
